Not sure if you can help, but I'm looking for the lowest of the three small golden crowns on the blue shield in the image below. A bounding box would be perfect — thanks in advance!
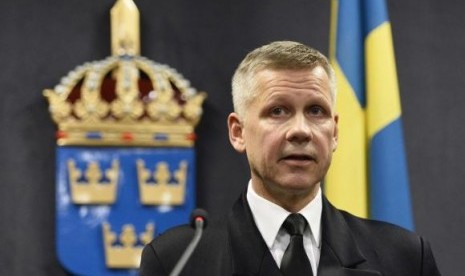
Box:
[102,223,155,268]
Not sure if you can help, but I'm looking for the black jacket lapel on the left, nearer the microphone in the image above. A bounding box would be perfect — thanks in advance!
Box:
[228,193,281,276]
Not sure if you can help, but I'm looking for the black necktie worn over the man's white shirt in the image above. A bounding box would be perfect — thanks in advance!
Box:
[280,214,313,276]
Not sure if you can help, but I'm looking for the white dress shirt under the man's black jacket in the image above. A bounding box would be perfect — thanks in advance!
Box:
[247,181,323,276]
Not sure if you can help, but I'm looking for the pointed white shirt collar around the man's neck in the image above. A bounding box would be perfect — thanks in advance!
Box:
[247,180,323,248]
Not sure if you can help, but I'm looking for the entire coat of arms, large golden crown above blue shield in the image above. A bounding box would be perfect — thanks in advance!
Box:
[44,0,206,275]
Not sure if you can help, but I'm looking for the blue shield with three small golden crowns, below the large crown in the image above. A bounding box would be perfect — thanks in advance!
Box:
[56,146,195,275]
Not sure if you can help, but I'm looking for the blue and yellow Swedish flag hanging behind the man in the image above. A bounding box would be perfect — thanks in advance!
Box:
[325,0,413,229]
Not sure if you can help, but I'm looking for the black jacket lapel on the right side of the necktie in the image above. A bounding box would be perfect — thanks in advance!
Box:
[318,197,381,276]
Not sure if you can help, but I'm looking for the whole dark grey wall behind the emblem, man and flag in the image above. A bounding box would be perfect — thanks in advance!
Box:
[0,0,465,275]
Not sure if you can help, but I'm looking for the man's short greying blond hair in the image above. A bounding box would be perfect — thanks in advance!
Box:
[232,41,336,117]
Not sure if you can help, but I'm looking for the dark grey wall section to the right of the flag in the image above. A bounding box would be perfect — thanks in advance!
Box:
[389,1,465,270]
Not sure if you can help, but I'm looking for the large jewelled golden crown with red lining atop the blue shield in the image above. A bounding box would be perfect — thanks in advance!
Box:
[44,0,206,147]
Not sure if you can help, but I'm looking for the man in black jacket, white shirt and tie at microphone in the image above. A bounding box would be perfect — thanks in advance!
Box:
[140,41,440,276]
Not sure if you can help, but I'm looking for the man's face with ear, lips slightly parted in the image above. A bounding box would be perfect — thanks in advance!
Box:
[228,67,338,205]
